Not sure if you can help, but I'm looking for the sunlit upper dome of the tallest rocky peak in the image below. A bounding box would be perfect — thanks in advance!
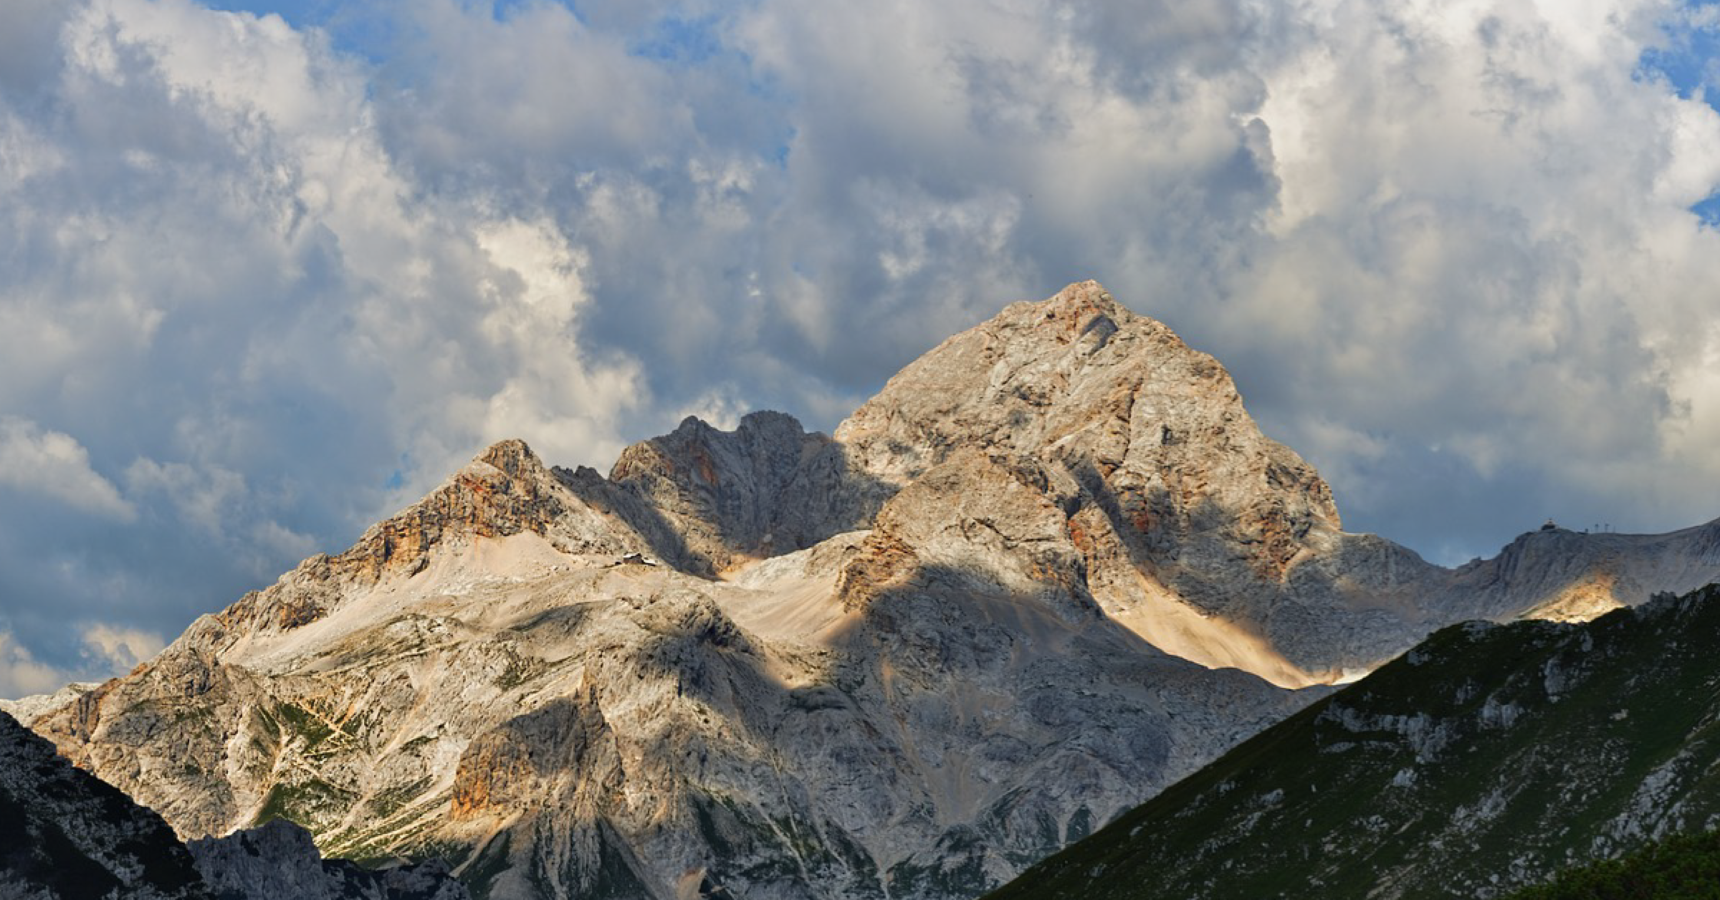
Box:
[836,280,1340,536]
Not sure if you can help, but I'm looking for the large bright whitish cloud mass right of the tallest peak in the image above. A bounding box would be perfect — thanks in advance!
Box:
[1219,2,1720,549]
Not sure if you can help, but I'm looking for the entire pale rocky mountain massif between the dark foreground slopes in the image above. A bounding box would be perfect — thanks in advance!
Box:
[29,282,1720,900]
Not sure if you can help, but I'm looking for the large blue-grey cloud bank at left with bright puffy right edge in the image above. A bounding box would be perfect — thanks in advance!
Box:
[0,0,648,666]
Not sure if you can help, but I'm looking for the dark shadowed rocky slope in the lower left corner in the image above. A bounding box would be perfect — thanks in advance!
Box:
[0,712,470,900]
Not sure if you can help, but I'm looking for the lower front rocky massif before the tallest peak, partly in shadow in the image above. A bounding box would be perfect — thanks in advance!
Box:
[16,435,1299,897]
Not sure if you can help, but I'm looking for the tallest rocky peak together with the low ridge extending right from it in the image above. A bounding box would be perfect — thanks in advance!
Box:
[836,282,1720,687]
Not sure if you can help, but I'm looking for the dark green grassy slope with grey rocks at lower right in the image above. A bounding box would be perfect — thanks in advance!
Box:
[987,585,1720,900]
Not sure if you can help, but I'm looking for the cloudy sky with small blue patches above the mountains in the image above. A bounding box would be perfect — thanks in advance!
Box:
[0,0,1720,697]
